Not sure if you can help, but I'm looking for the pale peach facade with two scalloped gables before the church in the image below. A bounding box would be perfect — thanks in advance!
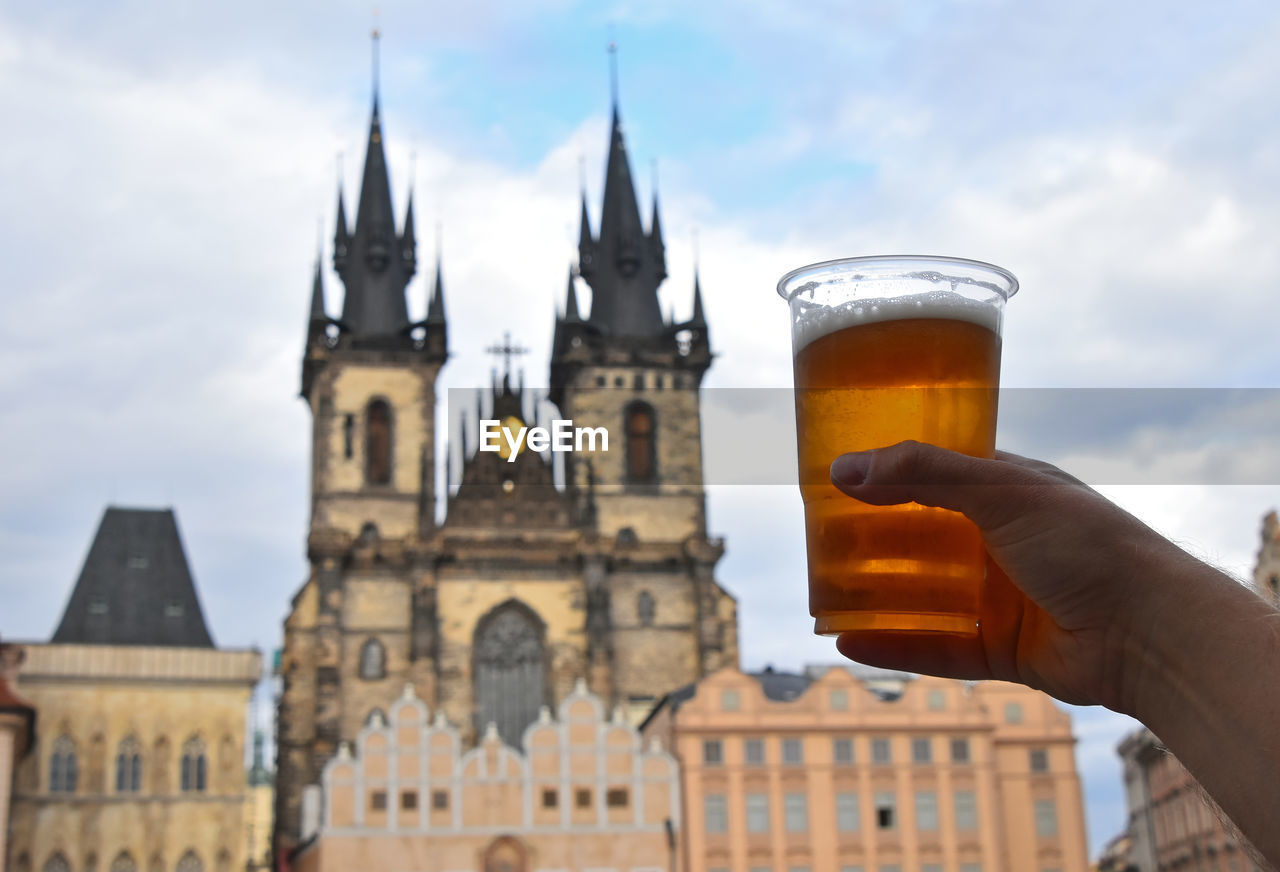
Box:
[294,682,680,872]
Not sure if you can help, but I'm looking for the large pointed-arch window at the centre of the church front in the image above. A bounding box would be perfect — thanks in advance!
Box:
[472,601,547,748]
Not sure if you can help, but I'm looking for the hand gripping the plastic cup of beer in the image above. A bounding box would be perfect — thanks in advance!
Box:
[831,442,1208,712]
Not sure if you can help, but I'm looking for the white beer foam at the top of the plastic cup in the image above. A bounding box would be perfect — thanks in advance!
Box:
[792,291,1001,352]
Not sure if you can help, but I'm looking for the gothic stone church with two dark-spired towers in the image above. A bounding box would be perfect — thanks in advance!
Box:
[275,69,737,850]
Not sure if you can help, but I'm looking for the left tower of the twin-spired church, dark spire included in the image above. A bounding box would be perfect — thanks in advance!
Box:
[276,50,448,835]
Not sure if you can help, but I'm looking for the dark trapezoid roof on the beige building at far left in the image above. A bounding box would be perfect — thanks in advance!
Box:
[52,506,214,648]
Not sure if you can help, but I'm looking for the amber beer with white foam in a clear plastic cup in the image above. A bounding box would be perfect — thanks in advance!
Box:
[780,254,1016,635]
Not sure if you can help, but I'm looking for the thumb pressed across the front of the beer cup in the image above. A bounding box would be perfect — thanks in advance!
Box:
[831,442,1043,530]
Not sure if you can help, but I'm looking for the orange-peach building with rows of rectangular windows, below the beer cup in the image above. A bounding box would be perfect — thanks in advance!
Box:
[643,667,1088,872]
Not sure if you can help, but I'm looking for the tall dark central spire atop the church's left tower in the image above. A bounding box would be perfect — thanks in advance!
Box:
[334,31,413,337]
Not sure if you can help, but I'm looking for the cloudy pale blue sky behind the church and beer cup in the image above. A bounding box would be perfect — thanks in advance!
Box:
[0,0,1280,853]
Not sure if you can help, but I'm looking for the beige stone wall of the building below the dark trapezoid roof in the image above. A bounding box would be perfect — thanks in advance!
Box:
[9,645,261,872]
